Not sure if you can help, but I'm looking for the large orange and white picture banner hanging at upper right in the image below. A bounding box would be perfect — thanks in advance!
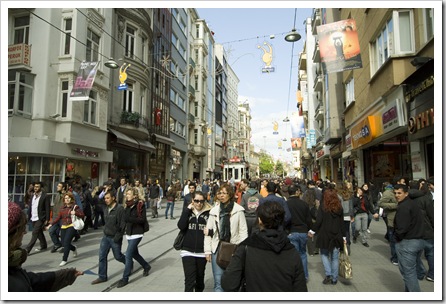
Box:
[317,19,362,74]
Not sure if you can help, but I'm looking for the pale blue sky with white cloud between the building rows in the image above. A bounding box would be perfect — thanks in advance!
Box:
[197,2,312,161]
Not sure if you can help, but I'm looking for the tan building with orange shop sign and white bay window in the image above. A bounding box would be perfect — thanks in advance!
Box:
[306,8,434,185]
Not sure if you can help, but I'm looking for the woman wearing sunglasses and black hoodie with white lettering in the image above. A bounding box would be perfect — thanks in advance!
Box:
[177,191,212,292]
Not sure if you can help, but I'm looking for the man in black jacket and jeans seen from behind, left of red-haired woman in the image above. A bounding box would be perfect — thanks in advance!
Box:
[287,185,312,281]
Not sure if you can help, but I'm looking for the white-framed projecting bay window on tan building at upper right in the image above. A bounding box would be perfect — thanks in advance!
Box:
[370,9,415,75]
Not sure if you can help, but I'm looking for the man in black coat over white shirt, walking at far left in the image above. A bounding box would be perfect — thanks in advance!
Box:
[26,182,51,254]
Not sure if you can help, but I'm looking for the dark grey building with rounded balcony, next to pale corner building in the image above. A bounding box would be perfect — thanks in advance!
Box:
[106,8,156,182]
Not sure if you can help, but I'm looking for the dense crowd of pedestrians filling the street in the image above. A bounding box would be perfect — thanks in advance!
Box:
[8,172,434,292]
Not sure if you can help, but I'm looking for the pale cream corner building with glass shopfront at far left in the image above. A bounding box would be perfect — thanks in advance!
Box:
[8,8,113,202]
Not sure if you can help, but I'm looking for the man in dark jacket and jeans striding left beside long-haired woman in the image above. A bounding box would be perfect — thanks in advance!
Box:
[91,191,125,285]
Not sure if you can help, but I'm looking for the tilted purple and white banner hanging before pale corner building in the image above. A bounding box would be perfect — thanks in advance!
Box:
[70,61,99,100]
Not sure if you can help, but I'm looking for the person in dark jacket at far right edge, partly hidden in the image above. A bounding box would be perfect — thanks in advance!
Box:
[409,179,434,282]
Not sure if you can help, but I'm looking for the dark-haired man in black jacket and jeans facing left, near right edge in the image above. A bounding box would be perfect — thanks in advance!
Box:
[394,184,424,292]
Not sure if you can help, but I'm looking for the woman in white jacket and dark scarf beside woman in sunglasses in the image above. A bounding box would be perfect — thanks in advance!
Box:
[204,184,248,292]
